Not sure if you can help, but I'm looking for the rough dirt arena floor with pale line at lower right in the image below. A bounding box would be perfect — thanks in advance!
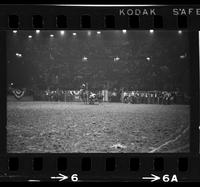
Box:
[7,101,190,153]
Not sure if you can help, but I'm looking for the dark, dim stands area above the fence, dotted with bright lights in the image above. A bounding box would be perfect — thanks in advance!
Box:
[7,30,190,92]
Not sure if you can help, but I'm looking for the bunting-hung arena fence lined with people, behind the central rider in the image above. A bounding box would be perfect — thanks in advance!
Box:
[7,89,190,104]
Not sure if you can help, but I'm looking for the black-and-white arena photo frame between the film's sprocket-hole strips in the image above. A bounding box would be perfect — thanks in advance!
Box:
[6,29,191,153]
